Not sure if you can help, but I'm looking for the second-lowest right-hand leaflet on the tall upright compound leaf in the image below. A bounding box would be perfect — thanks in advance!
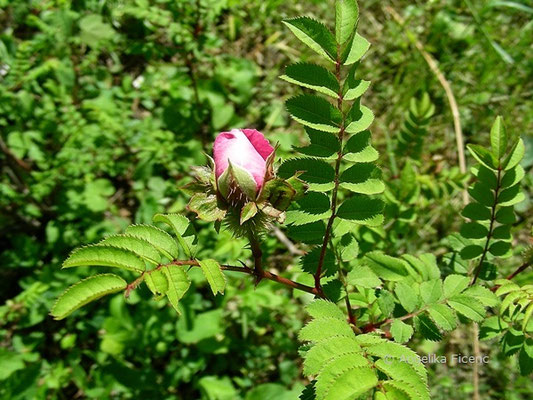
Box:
[340,163,385,194]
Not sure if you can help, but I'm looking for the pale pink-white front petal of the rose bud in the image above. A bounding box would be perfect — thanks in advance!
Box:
[213,129,270,190]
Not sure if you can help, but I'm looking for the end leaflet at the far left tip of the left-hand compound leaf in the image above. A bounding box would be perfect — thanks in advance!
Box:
[50,274,128,319]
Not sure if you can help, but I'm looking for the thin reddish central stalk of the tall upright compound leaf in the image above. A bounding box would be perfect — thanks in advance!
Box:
[315,45,346,293]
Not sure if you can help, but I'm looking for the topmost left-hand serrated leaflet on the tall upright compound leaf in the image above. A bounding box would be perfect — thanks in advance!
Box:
[283,17,337,62]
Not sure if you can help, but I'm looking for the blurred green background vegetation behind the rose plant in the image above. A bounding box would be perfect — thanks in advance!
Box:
[0,0,533,400]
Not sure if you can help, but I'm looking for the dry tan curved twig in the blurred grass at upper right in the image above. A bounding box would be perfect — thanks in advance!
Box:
[384,6,468,203]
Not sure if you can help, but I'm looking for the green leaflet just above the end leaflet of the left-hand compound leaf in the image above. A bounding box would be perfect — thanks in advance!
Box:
[63,245,146,272]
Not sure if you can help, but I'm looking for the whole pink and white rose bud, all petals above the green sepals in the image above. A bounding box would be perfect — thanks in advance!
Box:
[213,129,274,197]
